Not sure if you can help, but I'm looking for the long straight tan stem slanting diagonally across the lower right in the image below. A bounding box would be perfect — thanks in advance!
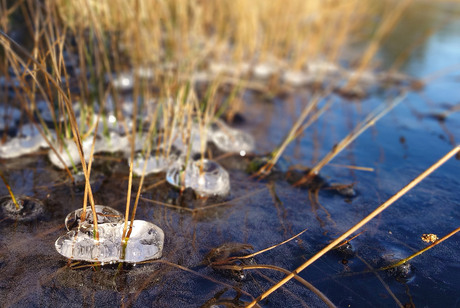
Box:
[248,145,460,307]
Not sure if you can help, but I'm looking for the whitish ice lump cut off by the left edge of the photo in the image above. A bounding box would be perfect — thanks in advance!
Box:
[0,124,53,158]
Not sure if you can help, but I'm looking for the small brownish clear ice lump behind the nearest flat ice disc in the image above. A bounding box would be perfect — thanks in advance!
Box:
[65,205,124,231]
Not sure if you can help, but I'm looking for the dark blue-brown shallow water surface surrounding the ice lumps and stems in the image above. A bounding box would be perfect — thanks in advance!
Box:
[0,4,460,307]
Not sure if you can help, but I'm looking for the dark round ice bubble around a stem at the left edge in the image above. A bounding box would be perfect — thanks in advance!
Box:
[0,196,44,221]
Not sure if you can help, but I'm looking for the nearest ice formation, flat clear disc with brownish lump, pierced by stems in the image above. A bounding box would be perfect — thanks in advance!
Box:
[55,205,164,263]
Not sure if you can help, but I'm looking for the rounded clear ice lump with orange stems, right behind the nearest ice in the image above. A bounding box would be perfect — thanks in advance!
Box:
[166,159,230,196]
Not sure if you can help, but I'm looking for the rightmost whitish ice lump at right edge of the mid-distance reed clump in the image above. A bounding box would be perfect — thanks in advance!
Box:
[209,120,254,153]
